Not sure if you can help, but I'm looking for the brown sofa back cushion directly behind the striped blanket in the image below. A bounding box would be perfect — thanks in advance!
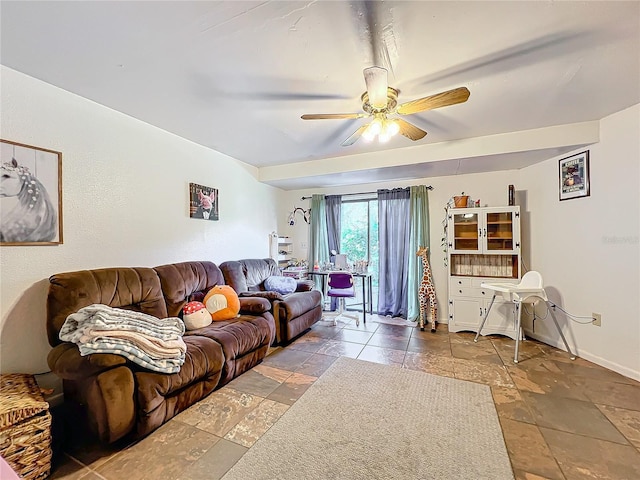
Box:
[47,267,168,347]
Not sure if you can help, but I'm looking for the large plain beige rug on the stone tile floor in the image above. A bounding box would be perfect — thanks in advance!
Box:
[223,357,513,480]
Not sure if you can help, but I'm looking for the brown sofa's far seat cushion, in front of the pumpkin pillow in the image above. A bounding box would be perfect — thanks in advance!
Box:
[184,313,275,384]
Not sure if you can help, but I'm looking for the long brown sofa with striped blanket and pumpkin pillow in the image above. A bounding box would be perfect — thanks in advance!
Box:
[47,262,275,443]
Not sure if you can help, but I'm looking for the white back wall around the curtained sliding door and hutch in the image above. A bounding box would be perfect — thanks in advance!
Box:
[278,169,518,323]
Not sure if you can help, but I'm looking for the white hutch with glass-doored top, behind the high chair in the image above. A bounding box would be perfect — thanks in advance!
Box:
[447,206,521,339]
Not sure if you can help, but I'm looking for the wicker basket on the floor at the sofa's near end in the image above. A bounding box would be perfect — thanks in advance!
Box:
[0,374,52,479]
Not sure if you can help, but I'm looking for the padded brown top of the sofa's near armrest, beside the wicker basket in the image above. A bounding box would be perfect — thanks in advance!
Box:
[47,342,127,380]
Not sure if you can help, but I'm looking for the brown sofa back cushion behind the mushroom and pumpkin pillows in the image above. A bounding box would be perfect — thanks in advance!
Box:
[154,262,224,317]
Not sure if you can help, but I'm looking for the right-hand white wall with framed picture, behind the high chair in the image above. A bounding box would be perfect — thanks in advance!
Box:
[517,105,640,380]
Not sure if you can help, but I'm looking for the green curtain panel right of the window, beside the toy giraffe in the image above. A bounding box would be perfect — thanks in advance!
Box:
[407,185,431,322]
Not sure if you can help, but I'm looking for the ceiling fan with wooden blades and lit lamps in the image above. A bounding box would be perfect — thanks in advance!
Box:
[301,67,470,147]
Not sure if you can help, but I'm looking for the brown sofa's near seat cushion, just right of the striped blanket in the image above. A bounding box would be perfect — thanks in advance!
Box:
[135,329,224,420]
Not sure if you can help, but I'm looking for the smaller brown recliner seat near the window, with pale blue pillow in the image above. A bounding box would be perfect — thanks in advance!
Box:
[220,258,322,344]
